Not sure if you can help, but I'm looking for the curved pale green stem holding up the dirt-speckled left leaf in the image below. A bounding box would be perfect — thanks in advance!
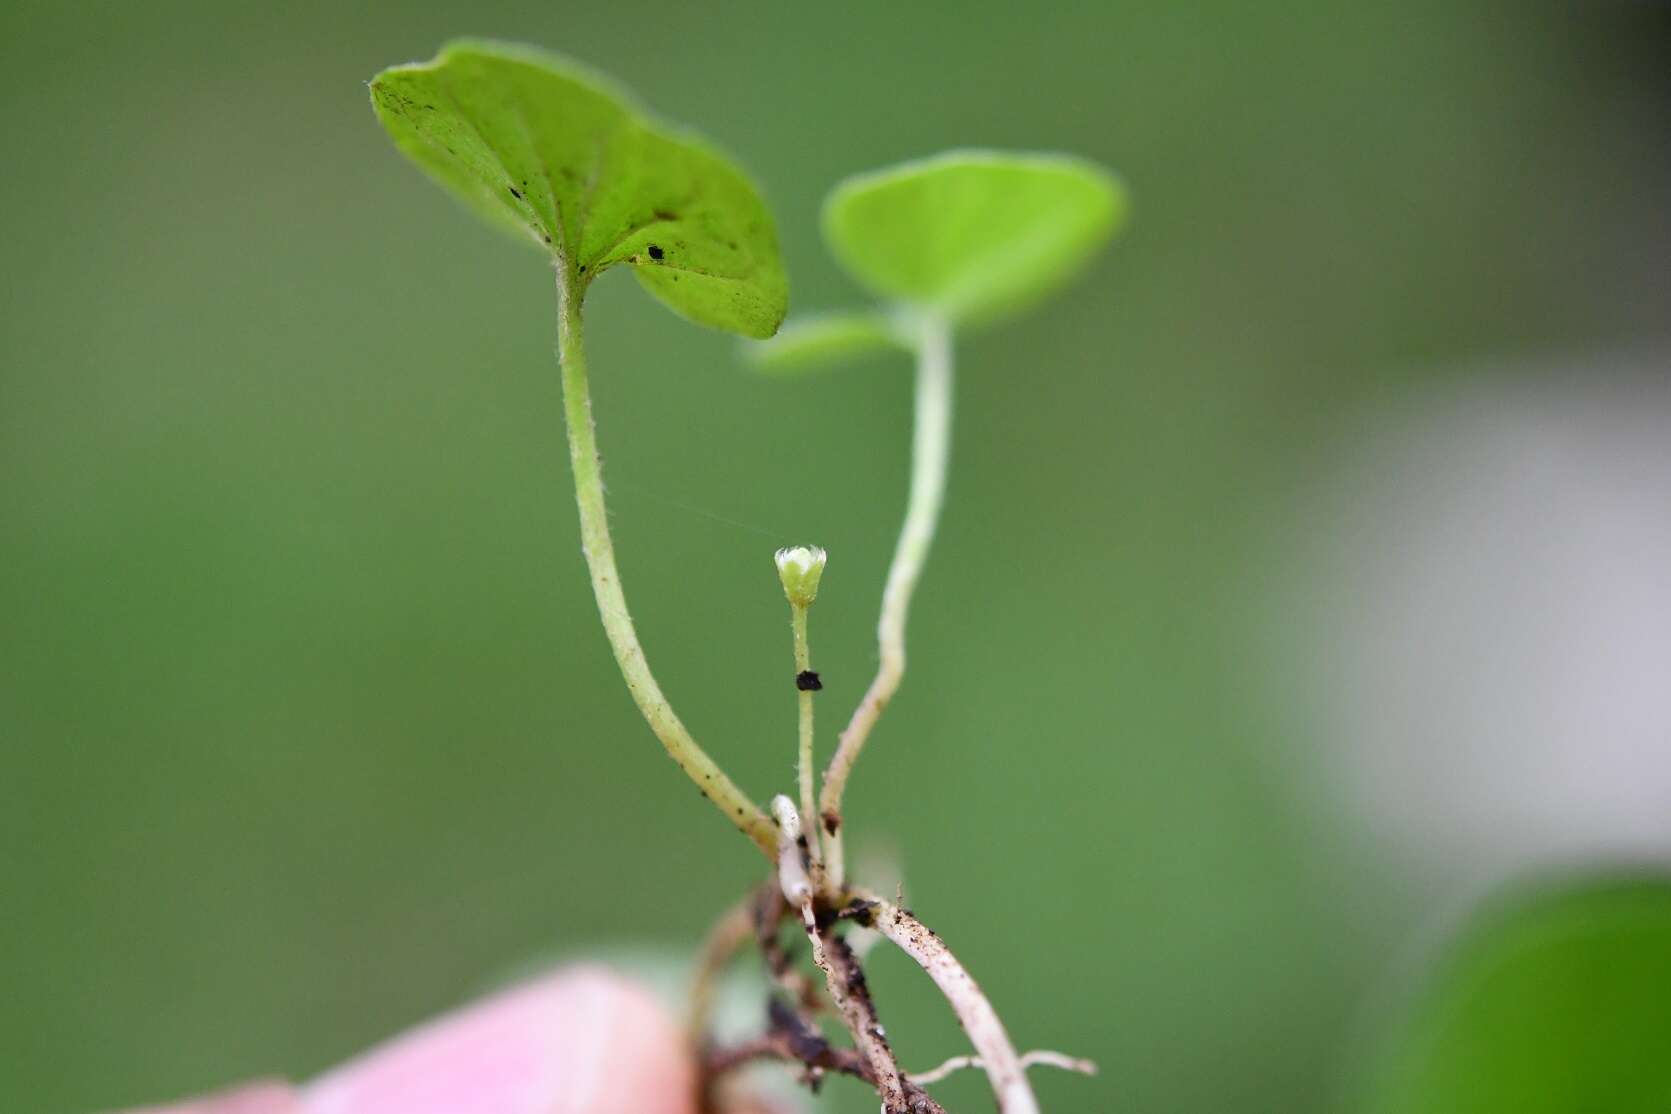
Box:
[556,262,777,855]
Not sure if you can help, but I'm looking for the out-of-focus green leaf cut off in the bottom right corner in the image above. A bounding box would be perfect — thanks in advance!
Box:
[1369,879,1671,1114]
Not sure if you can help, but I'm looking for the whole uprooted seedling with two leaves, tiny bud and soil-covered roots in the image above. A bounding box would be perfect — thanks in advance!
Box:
[371,42,1125,1114]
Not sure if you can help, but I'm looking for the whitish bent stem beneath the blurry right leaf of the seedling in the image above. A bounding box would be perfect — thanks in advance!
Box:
[819,308,952,887]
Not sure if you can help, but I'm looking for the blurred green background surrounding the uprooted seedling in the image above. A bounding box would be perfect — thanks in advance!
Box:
[0,0,1671,1114]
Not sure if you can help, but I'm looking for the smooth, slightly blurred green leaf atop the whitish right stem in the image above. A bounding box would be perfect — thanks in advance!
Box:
[824,150,1126,321]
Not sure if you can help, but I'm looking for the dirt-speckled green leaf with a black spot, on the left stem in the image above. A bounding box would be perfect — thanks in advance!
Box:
[371,42,787,337]
